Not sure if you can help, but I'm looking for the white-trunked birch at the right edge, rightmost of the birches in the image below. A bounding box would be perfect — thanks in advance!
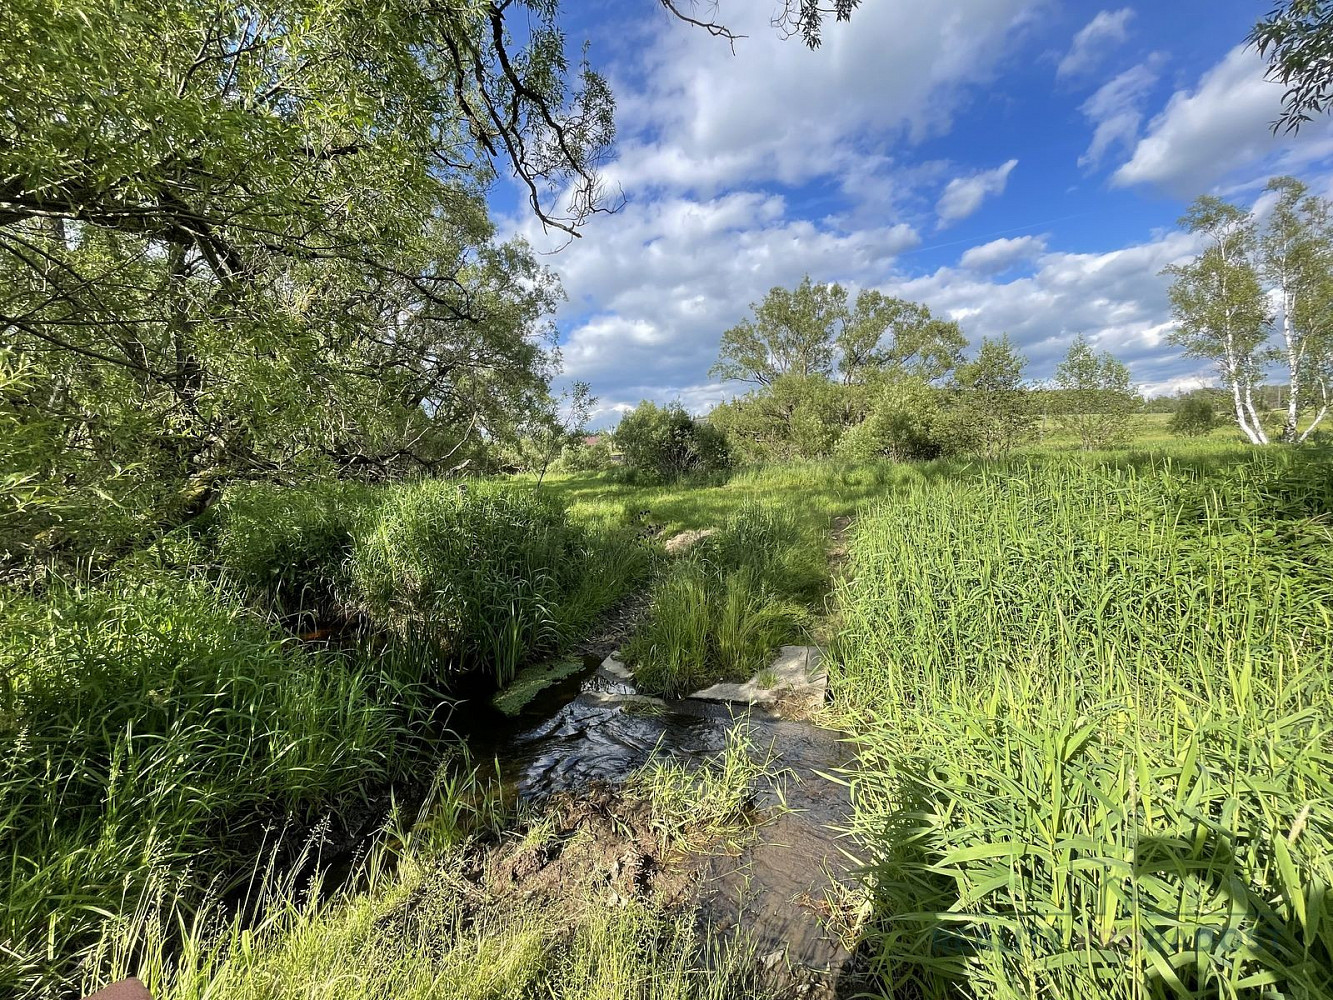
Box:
[1260,177,1333,443]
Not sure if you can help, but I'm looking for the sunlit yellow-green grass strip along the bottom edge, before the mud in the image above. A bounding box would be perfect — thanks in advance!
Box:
[85,816,769,1000]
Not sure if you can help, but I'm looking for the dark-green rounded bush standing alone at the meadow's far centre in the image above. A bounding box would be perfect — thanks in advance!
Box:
[616,401,730,481]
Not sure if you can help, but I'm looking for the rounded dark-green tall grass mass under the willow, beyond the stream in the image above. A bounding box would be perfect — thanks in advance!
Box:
[213,480,647,684]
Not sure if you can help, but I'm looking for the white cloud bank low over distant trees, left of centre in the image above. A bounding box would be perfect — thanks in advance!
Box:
[514,192,921,416]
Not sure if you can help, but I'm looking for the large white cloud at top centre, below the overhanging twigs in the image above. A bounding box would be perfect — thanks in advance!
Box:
[605,0,1034,196]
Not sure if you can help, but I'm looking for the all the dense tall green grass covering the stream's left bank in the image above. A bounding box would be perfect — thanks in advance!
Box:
[0,483,647,996]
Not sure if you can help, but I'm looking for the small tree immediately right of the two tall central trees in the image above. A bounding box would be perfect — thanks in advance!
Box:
[945,335,1033,459]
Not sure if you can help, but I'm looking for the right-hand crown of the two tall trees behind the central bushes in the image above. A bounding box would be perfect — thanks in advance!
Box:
[834,289,968,383]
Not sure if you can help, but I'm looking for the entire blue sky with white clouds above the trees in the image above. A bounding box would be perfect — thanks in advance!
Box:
[495,0,1333,427]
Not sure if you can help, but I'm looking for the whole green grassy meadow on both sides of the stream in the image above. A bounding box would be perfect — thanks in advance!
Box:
[0,416,1333,1000]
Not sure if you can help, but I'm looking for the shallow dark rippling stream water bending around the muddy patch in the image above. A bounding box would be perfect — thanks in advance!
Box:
[453,657,854,972]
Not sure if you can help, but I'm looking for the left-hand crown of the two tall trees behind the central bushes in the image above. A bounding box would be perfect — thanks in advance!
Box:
[709,275,846,385]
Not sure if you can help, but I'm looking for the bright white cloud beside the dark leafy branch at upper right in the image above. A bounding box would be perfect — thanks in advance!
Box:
[1113,45,1333,197]
